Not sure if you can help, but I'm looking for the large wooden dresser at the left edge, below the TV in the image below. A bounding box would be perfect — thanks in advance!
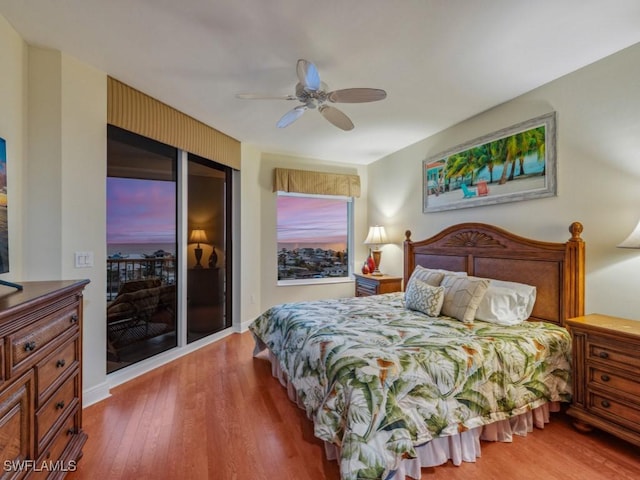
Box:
[0,280,89,479]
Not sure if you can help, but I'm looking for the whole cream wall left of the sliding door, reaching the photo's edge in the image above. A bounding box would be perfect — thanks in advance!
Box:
[0,16,107,402]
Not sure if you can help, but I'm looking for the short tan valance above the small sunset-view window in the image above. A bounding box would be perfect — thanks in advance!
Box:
[273,168,360,197]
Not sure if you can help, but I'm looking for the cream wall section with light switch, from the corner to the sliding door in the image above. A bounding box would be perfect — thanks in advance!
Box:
[23,47,108,397]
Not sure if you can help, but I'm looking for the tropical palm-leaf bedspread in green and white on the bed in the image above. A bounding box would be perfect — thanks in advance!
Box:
[249,293,571,479]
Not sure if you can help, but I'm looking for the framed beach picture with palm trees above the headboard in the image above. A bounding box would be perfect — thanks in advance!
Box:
[422,112,556,213]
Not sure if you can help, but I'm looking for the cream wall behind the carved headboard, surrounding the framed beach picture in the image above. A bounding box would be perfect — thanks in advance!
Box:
[369,44,640,319]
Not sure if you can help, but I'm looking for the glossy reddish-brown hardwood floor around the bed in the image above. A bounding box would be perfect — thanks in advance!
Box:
[67,332,640,480]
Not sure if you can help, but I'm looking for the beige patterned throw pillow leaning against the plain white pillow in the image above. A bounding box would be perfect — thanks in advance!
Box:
[442,275,490,324]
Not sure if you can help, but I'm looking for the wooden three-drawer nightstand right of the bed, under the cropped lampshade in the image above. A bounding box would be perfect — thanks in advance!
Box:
[567,314,640,446]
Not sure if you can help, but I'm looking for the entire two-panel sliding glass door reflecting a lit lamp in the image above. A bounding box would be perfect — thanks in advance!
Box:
[106,126,232,373]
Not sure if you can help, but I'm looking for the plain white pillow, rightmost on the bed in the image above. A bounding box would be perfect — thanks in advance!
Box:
[476,280,536,325]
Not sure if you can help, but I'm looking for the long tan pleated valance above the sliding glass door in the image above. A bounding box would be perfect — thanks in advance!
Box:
[107,77,240,170]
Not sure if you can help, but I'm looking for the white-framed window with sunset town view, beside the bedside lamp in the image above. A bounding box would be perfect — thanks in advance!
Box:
[277,192,353,284]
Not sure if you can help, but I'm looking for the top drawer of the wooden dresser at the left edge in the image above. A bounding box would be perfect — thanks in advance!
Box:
[7,308,79,375]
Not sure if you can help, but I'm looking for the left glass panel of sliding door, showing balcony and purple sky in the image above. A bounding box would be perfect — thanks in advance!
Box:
[106,126,179,373]
